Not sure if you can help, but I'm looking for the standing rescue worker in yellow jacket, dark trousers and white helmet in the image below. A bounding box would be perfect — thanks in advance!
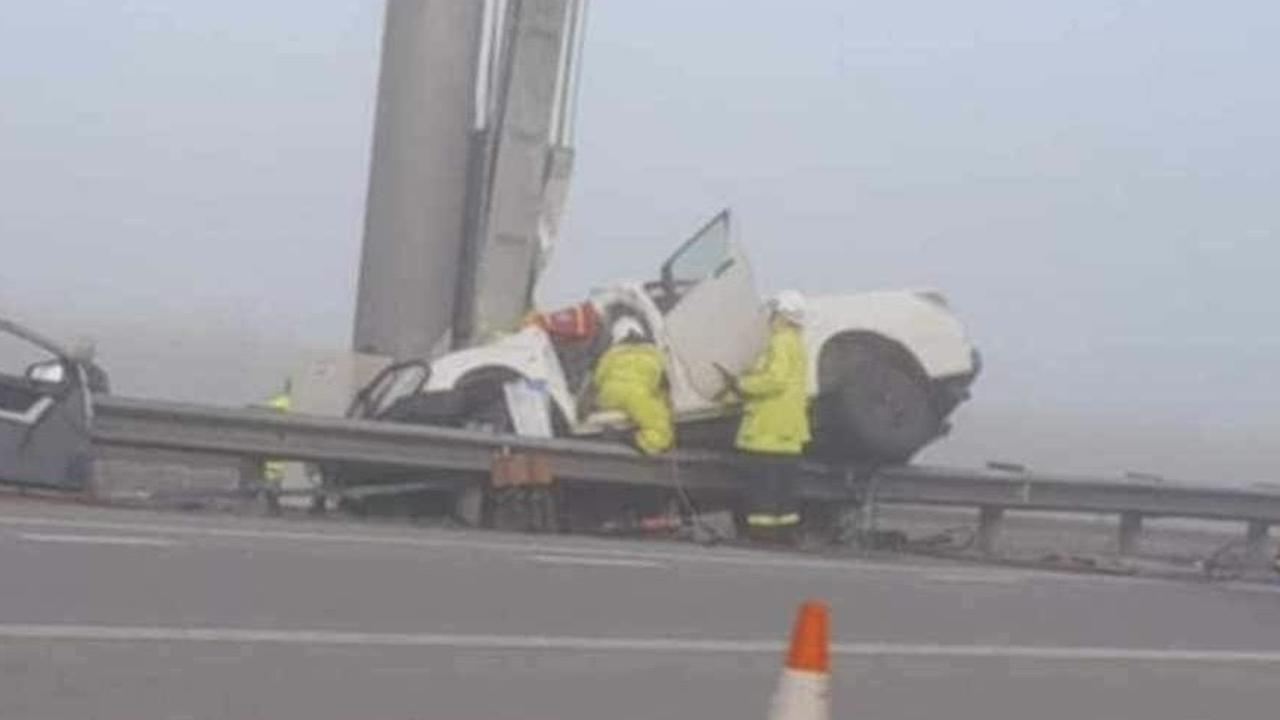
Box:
[722,291,810,539]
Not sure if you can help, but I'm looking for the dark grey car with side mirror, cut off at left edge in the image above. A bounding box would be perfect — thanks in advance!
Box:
[0,319,93,489]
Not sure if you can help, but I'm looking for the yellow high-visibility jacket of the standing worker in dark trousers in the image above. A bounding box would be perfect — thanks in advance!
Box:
[736,319,810,455]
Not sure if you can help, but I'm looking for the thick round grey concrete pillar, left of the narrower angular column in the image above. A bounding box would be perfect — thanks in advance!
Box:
[353,0,485,360]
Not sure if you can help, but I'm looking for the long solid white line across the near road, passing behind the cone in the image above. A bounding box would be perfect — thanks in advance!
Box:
[0,624,1280,665]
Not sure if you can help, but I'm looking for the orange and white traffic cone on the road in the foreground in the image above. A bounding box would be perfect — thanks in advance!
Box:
[769,601,831,720]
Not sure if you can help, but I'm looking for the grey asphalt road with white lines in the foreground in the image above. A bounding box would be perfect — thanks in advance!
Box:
[0,503,1280,720]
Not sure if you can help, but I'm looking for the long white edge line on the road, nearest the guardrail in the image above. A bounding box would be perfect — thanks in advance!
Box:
[0,515,1167,585]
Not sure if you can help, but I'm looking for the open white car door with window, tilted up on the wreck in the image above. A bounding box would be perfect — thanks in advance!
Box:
[660,210,768,401]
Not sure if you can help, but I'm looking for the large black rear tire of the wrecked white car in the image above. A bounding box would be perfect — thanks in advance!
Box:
[819,341,942,462]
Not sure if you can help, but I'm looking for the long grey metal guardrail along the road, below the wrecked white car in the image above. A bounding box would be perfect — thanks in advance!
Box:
[93,396,1280,548]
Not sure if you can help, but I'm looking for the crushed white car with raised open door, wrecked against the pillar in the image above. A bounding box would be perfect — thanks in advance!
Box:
[356,210,979,462]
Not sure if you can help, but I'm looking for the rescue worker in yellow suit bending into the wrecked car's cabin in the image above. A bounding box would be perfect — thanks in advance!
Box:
[593,318,676,455]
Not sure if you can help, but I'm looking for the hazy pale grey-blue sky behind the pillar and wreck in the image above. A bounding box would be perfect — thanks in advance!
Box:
[0,0,1280,479]
